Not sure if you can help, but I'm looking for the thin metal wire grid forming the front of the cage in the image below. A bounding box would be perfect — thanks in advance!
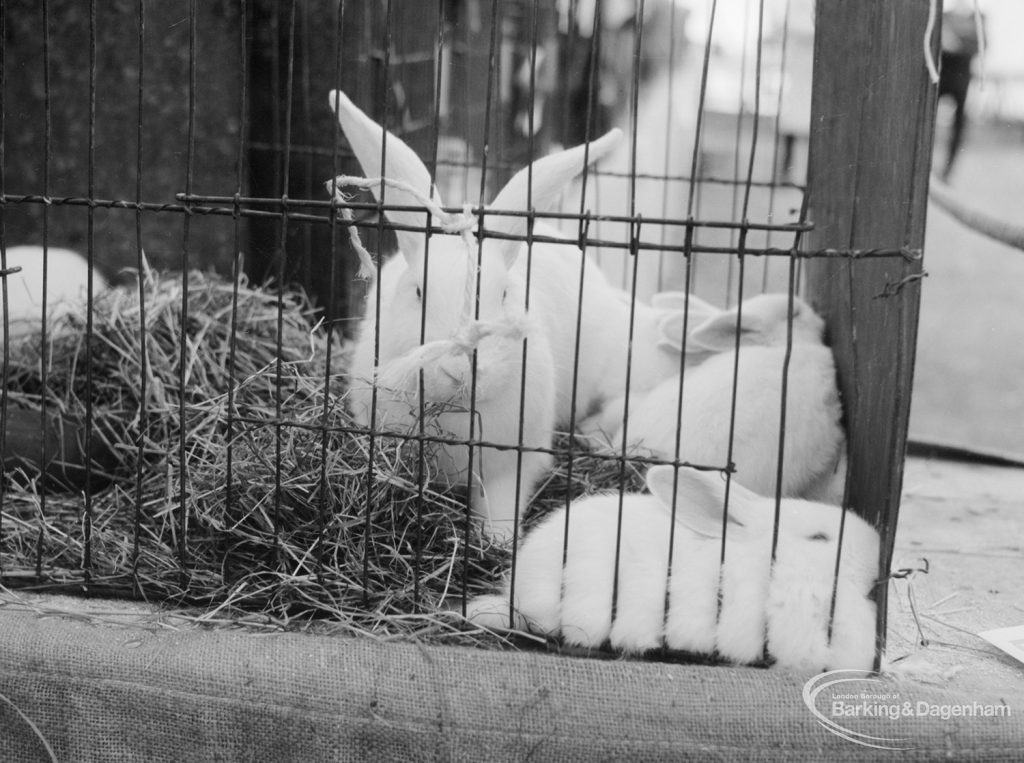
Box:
[0,0,908,667]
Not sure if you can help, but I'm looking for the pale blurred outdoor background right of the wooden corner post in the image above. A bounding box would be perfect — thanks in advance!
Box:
[910,0,1024,458]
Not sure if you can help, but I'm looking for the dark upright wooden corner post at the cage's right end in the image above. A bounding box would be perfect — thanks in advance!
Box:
[807,0,938,648]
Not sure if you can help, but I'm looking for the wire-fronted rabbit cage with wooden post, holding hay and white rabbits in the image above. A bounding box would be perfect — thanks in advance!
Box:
[0,0,937,696]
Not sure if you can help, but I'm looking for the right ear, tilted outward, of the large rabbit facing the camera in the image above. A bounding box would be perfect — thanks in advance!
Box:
[483,128,623,268]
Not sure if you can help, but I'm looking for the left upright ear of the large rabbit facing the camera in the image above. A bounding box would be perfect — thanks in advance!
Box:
[330,90,441,270]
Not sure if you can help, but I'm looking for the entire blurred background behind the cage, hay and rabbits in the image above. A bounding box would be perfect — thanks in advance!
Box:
[6,0,1024,457]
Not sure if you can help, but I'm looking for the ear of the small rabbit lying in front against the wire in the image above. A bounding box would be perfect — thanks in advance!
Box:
[647,466,764,538]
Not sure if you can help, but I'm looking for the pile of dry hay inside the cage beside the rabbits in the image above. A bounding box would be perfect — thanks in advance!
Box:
[0,272,640,637]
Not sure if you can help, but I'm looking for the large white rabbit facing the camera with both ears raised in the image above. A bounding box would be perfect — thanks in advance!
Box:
[331,91,675,538]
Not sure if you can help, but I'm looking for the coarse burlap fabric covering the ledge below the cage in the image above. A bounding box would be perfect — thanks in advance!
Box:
[0,607,1024,761]
